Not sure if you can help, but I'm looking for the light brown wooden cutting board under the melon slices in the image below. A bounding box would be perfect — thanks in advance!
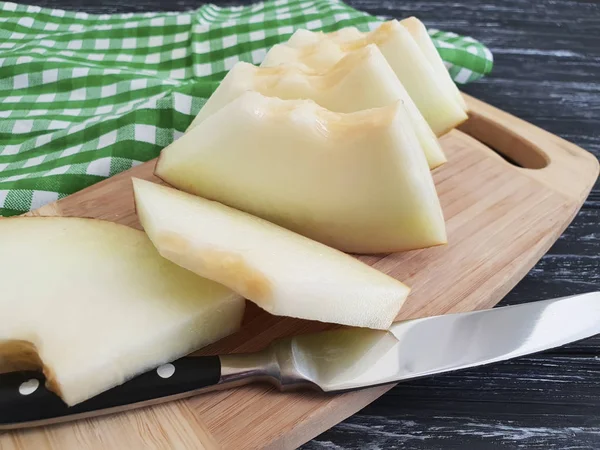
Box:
[0,93,598,450]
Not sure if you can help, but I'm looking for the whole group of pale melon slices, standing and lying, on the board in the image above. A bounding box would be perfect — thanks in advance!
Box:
[0,18,467,404]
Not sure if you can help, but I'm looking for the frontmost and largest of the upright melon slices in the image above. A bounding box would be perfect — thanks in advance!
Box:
[156,92,446,253]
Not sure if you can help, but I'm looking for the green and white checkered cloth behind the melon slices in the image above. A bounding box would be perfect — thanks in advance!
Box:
[0,0,492,216]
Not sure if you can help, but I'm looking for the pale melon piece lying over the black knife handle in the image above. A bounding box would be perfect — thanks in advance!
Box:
[0,217,245,405]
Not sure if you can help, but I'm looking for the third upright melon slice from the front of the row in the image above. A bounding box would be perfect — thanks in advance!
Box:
[262,20,467,136]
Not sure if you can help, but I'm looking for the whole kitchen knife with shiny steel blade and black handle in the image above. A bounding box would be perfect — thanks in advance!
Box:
[0,292,600,429]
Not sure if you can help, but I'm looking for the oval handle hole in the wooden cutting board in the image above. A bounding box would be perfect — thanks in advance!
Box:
[459,113,550,169]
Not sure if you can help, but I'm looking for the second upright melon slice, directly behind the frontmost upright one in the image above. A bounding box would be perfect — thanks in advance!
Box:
[188,44,446,169]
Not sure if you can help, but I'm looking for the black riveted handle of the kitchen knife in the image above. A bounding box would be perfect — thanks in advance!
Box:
[0,356,221,430]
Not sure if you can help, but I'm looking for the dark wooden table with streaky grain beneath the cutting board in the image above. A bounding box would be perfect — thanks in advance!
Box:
[41,0,600,450]
